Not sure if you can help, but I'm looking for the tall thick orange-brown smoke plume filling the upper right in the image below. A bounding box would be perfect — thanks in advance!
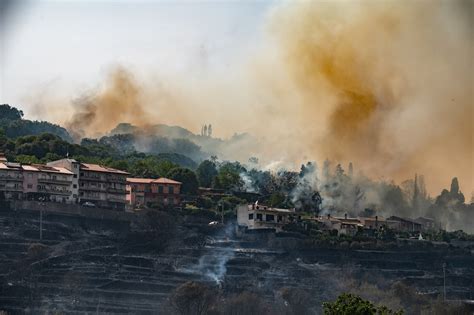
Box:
[264,1,474,194]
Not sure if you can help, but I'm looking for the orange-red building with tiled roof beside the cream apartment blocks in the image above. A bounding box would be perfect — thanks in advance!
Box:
[126,177,182,208]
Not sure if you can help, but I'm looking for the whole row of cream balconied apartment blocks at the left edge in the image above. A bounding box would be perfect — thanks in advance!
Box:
[0,154,130,210]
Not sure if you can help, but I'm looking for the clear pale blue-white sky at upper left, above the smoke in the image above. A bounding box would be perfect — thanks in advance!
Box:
[0,0,272,118]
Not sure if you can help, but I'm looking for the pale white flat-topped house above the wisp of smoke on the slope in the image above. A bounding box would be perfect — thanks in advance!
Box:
[237,203,295,232]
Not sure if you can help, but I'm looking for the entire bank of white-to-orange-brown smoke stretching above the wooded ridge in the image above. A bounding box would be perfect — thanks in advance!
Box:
[31,0,474,192]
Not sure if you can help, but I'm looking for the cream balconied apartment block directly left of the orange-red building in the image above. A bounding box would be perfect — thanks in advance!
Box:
[48,159,129,210]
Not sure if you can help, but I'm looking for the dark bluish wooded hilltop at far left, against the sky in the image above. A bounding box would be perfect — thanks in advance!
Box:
[0,104,72,142]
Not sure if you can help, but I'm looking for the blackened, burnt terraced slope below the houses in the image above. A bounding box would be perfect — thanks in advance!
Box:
[0,212,474,314]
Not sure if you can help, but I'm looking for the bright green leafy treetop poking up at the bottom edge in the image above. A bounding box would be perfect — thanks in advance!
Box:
[323,293,403,315]
